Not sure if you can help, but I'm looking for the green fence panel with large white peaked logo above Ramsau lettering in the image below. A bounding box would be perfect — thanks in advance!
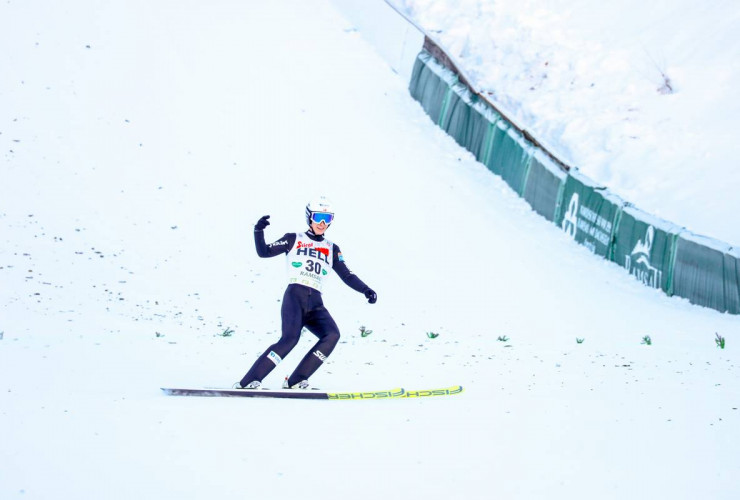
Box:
[611,206,684,294]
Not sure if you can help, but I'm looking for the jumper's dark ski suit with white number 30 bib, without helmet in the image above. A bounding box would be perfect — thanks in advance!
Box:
[240,229,370,387]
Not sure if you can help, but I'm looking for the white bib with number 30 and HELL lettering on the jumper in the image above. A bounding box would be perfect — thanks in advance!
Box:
[287,233,334,291]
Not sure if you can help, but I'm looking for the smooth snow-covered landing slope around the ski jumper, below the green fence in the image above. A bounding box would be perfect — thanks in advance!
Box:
[0,0,740,500]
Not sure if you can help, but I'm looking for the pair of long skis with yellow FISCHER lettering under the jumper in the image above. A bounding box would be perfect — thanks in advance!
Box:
[161,385,463,400]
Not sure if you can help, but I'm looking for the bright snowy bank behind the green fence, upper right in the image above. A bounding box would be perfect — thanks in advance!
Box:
[390,0,740,246]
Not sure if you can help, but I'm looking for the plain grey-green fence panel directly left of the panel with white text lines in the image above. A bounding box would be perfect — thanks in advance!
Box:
[522,151,568,221]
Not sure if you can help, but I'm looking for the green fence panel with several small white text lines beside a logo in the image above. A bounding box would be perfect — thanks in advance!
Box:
[555,170,625,259]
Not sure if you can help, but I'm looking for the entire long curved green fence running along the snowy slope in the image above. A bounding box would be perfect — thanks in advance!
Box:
[409,47,740,314]
